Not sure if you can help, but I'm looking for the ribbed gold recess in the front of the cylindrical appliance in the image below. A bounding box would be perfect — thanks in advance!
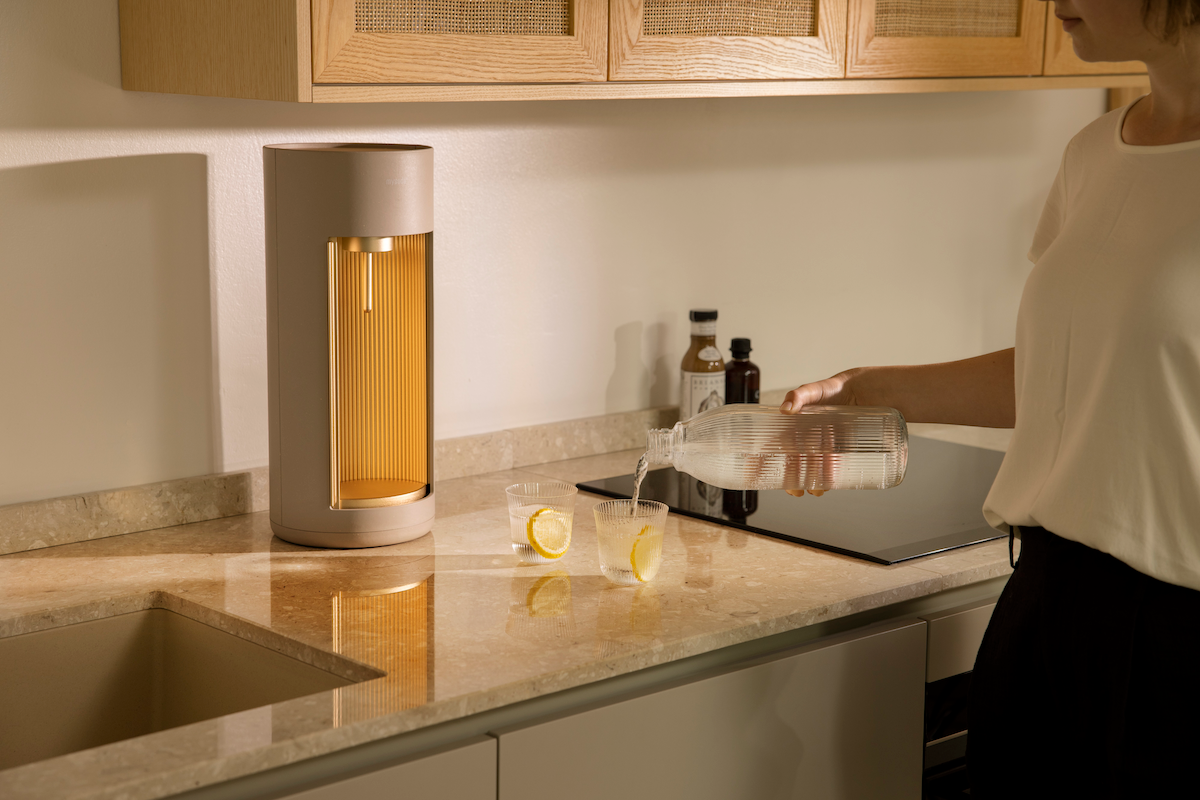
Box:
[329,234,430,509]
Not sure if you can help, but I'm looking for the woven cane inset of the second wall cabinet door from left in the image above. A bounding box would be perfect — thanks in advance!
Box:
[642,0,817,36]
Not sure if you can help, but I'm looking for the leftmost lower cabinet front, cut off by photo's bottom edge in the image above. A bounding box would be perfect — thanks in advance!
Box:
[276,736,496,800]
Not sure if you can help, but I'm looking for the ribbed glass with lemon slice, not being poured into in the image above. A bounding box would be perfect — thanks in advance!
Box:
[504,481,580,564]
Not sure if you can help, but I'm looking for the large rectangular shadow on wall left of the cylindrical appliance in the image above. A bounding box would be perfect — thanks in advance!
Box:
[0,154,217,505]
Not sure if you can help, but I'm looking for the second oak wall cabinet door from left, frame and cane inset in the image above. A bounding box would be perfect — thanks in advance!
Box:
[608,0,846,80]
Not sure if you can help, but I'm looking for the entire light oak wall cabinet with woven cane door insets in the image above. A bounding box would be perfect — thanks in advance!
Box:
[119,0,1145,103]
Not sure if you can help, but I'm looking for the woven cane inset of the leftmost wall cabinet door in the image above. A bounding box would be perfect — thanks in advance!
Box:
[354,0,571,36]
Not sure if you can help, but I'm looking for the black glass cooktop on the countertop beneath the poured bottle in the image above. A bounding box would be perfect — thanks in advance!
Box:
[580,437,1004,564]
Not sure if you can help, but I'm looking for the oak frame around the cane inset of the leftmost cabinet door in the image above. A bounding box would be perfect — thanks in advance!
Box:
[312,0,608,84]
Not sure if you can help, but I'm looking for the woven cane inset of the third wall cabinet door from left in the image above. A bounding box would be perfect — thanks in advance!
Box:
[875,0,1021,37]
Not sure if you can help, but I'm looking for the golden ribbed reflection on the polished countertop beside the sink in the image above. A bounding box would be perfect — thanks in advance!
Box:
[332,579,433,726]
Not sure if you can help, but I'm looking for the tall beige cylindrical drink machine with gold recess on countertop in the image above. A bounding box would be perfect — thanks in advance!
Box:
[263,144,433,547]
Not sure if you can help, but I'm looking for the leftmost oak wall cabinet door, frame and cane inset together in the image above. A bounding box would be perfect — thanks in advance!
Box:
[312,0,608,84]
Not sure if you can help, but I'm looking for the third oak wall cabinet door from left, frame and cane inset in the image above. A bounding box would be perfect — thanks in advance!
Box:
[846,0,1046,78]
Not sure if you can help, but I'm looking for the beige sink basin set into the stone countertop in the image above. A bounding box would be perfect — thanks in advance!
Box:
[0,608,366,770]
